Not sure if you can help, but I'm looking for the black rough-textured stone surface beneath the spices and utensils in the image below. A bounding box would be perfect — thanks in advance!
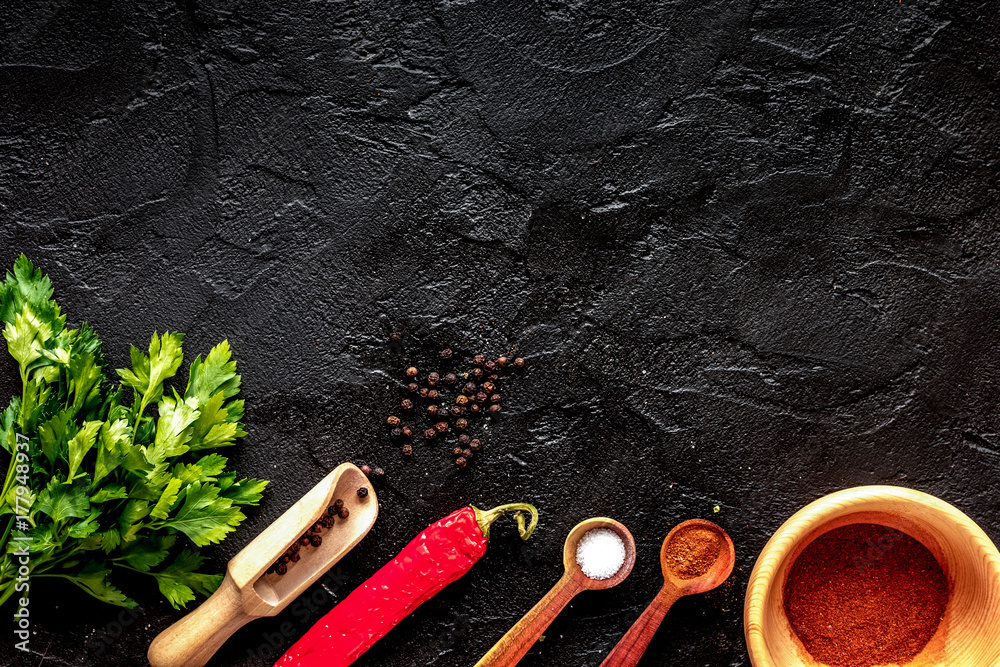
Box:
[0,0,1000,667]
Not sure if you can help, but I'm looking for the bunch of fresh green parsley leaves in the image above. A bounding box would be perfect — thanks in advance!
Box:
[0,255,267,608]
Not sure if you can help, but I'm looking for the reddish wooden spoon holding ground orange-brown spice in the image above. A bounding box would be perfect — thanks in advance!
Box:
[601,519,736,667]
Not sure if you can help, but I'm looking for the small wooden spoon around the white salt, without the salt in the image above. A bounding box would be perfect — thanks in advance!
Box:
[474,517,635,667]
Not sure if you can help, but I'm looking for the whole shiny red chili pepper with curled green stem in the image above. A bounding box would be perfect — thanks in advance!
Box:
[274,503,538,667]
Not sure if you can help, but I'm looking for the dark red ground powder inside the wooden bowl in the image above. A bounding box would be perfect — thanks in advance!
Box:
[784,523,948,667]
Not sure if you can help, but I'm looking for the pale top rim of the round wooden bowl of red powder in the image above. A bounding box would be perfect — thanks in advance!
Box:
[743,485,1000,667]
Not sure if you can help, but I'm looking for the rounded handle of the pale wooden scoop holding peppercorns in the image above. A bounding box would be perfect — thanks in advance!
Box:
[146,573,256,667]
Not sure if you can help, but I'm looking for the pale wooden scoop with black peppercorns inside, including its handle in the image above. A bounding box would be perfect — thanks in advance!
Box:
[147,463,378,667]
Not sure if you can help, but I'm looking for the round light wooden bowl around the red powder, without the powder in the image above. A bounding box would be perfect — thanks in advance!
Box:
[743,486,1000,667]
